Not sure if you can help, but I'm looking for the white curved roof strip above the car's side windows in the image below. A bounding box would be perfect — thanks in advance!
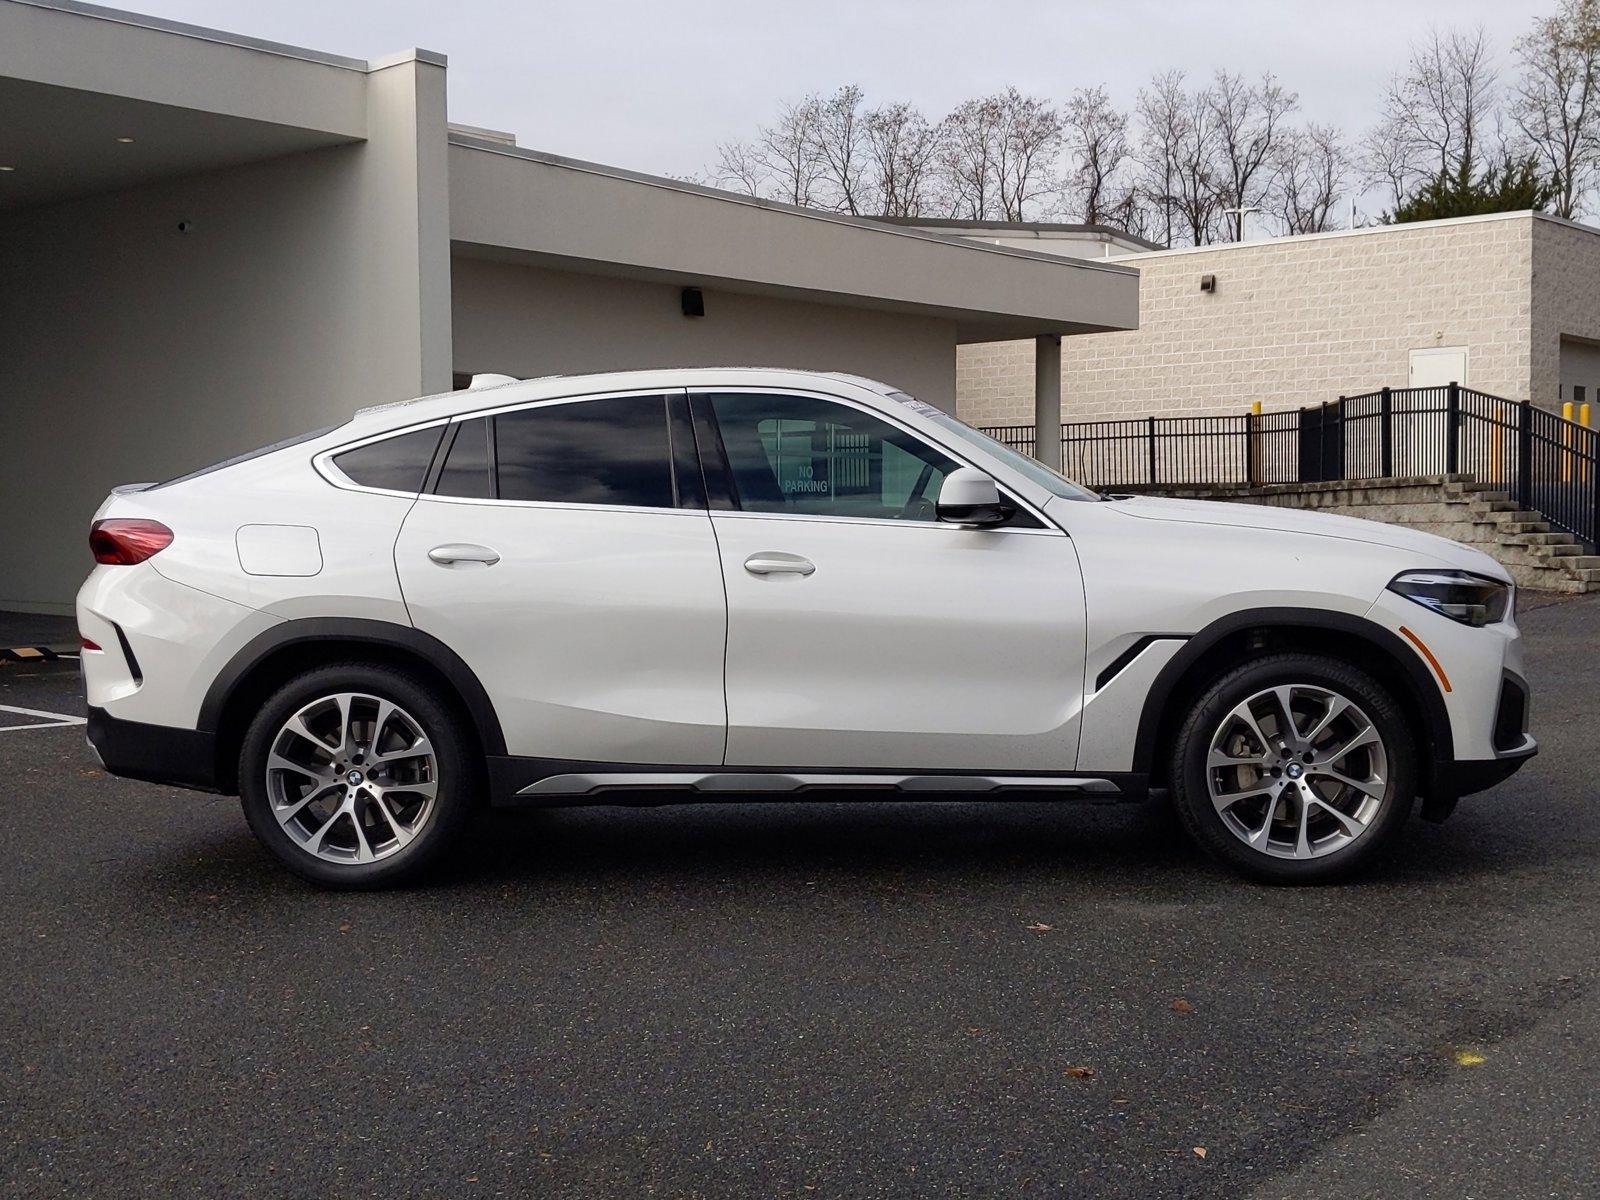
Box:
[346,374,899,435]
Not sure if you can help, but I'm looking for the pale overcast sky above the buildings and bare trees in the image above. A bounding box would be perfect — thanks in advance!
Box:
[134,0,1554,188]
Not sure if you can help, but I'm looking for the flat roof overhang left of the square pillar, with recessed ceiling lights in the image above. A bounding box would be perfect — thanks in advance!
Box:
[0,0,409,210]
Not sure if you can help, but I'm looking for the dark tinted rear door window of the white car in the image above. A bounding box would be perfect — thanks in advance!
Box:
[494,395,675,509]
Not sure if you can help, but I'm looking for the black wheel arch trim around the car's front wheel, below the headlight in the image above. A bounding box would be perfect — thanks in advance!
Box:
[1133,608,1454,787]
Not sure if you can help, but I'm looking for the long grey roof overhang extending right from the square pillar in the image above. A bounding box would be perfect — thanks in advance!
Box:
[450,134,1139,342]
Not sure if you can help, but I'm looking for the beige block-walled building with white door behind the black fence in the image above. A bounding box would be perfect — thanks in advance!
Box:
[957,213,1600,426]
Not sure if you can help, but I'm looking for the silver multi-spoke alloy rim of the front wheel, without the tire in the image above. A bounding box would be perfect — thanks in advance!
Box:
[1205,683,1389,859]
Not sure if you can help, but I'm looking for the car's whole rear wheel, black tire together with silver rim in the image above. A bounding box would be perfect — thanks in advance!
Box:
[238,662,483,890]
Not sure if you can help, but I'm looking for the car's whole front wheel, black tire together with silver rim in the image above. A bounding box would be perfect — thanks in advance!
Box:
[1170,653,1418,883]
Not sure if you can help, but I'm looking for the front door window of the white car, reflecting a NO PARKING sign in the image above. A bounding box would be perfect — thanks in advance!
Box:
[710,392,960,522]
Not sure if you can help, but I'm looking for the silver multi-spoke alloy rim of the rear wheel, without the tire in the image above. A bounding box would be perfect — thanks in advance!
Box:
[267,691,438,864]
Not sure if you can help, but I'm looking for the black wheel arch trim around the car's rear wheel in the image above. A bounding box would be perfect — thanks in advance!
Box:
[198,616,506,755]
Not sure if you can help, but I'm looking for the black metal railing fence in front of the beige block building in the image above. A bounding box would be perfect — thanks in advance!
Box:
[984,384,1600,542]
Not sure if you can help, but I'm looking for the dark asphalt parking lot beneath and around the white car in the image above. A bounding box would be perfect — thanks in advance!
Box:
[0,598,1600,1197]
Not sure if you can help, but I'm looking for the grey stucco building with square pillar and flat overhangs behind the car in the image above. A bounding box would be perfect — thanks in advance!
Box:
[0,0,1139,613]
